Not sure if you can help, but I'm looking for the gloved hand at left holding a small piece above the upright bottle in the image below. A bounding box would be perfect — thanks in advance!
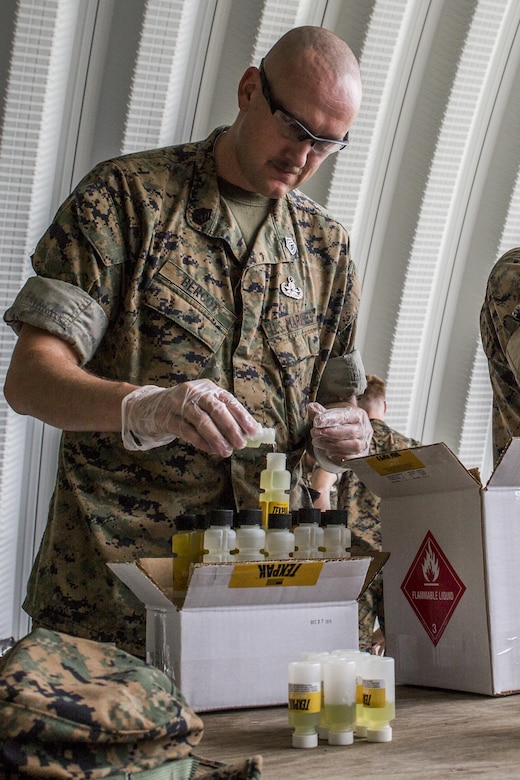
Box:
[121,379,261,458]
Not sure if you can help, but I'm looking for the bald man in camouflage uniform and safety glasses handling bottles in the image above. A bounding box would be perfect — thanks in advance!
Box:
[5,27,371,655]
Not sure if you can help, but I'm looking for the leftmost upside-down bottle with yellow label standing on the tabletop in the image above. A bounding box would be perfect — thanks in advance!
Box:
[288,661,321,748]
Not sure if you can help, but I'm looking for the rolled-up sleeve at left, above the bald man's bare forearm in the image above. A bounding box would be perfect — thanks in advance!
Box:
[4,276,108,365]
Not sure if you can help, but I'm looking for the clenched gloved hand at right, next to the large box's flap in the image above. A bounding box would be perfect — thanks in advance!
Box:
[308,402,373,474]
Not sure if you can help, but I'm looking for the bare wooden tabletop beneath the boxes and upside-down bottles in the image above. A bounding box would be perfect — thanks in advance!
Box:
[196,686,520,780]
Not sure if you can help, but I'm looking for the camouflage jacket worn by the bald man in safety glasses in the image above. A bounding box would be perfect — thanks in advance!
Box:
[5,130,364,655]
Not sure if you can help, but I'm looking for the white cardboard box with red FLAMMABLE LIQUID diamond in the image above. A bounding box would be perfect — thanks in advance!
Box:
[346,439,520,695]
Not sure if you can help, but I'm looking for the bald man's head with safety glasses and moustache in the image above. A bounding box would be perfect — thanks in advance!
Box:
[215,26,361,198]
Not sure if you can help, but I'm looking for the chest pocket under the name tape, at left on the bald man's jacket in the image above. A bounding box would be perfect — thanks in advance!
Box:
[144,262,236,353]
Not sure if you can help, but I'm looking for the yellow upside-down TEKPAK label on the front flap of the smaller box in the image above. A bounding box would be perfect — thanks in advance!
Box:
[228,560,323,588]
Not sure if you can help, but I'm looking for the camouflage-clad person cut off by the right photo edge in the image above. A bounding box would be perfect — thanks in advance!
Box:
[480,248,520,463]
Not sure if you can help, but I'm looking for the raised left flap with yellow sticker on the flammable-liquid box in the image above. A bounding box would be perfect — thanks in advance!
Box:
[349,442,479,498]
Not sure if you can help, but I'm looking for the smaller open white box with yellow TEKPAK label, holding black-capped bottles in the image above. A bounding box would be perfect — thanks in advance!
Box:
[108,554,388,711]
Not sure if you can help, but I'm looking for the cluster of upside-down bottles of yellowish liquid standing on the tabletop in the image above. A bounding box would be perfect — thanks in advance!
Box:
[288,650,395,748]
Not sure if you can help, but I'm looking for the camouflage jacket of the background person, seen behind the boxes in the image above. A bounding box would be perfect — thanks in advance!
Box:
[337,420,420,552]
